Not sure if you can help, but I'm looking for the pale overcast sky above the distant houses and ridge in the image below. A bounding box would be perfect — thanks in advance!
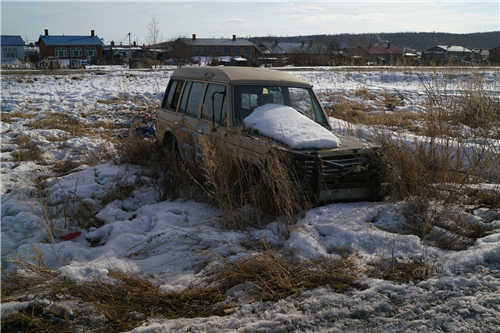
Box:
[1,0,500,44]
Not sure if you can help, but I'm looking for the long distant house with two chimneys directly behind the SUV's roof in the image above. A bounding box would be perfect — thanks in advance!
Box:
[181,34,257,60]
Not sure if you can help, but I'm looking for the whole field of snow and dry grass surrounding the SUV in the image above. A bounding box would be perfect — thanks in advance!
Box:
[0,68,500,332]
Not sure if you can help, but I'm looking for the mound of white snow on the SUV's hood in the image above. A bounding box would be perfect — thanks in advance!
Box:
[243,104,341,149]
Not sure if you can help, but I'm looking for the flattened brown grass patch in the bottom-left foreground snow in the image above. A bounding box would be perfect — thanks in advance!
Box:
[58,270,227,332]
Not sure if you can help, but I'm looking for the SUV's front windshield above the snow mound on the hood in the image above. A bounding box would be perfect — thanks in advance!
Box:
[233,85,327,125]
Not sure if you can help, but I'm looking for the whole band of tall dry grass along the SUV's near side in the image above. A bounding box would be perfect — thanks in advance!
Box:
[117,136,309,229]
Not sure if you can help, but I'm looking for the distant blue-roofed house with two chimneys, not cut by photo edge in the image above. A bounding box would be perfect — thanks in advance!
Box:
[38,29,104,63]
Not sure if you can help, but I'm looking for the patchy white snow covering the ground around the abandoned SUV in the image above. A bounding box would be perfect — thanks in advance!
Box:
[0,68,500,332]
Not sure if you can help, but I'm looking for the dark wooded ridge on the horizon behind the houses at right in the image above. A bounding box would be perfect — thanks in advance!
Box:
[251,31,500,51]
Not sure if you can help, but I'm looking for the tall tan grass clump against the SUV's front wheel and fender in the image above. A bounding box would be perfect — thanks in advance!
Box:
[200,140,310,229]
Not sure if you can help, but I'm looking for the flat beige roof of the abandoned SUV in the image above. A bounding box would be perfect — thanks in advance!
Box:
[172,66,312,87]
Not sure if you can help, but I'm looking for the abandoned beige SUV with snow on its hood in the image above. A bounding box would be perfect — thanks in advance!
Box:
[156,67,378,201]
